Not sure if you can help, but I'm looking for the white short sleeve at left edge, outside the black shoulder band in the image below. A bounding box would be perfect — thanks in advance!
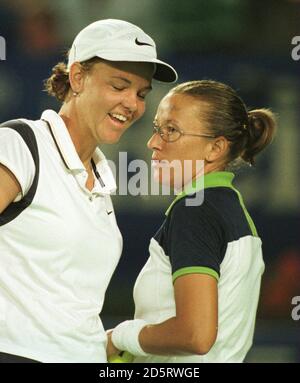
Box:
[0,127,35,202]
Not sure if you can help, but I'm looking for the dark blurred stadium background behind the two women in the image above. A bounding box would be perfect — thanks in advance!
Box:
[0,0,300,362]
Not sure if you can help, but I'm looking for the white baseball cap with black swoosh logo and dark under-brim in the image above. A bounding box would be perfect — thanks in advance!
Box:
[68,19,178,82]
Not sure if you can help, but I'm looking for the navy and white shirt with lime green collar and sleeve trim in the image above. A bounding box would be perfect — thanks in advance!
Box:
[134,172,264,362]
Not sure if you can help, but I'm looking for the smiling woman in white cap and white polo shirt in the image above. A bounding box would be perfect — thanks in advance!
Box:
[0,20,177,362]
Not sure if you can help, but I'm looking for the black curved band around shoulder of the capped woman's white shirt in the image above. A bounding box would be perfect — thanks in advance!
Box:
[0,120,40,226]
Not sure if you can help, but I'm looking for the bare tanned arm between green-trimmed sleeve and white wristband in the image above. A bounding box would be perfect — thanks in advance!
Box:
[139,274,218,355]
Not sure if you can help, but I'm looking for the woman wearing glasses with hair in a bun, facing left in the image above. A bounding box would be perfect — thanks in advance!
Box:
[108,81,276,362]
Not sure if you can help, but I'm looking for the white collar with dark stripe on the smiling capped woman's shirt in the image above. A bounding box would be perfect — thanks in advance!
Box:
[41,109,117,194]
